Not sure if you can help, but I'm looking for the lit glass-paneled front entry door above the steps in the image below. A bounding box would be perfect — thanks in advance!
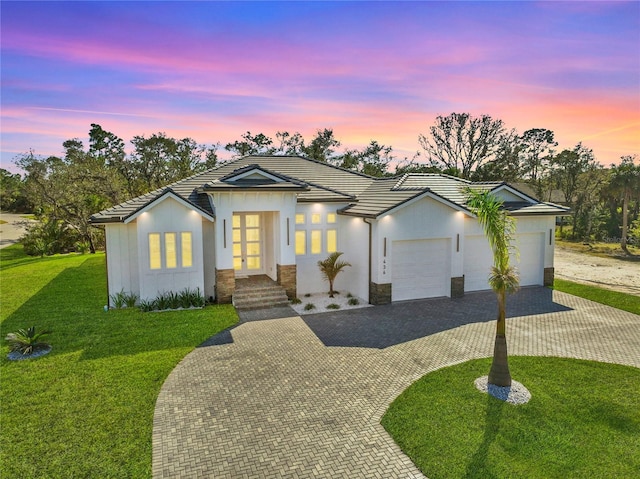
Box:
[233,213,264,276]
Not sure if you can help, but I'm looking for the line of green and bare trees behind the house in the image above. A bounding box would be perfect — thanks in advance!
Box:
[0,113,640,254]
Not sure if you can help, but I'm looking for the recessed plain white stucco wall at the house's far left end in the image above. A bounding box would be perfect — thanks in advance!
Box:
[105,223,140,295]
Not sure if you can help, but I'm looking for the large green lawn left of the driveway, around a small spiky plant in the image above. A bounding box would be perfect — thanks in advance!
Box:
[0,245,237,478]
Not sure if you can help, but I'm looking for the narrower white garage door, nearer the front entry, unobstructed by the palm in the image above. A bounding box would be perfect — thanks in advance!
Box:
[391,239,451,301]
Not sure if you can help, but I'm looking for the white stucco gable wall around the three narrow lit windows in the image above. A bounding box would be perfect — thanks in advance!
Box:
[136,196,205,299]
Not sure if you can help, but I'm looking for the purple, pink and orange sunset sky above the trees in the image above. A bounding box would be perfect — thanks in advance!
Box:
[0,1,640,171]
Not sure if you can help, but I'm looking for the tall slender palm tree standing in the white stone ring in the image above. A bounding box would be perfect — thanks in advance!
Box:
[466,189,519,386]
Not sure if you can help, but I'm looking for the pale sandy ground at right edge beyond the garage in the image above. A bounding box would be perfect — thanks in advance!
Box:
[555,246,640,296]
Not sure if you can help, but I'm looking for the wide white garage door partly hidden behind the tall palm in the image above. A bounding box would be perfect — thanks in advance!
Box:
[464,233,544,291]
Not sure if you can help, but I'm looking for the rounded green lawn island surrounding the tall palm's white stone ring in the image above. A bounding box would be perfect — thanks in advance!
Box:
[382,357,640,479]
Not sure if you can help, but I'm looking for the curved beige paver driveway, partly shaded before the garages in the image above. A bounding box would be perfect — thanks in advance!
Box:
[153,288,640,479]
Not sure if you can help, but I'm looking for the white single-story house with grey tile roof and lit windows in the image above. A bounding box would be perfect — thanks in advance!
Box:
[91,156,567,304]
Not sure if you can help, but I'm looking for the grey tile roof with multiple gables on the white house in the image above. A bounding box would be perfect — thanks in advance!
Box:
[91,155,568,224]
